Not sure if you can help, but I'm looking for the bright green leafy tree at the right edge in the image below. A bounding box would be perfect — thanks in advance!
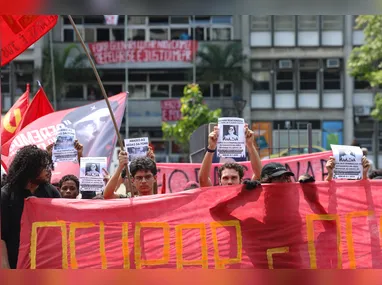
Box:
[348,15,382,120]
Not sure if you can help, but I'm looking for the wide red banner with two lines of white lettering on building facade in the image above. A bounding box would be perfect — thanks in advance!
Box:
[89,40,198,64]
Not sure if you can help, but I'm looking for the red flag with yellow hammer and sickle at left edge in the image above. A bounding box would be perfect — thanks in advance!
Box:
[1,84,30,145]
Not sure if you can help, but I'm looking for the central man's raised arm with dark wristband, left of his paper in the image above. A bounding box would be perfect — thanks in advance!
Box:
[199,126,219,187]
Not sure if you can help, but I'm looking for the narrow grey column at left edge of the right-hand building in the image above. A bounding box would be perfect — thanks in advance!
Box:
[241,15,252,123]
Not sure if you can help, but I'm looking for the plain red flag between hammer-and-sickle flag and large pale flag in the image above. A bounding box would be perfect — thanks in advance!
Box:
[1,87,54,156]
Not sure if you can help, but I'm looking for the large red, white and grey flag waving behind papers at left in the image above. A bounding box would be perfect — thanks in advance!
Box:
[2,92,127,183]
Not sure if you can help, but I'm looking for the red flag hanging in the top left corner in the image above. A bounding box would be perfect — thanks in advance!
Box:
[0,15,58,66]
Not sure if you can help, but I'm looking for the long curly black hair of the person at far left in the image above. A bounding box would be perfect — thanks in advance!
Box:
[7,145,53,191]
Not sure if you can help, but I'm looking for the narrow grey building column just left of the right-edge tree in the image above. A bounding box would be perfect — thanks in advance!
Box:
[344,15,354,145]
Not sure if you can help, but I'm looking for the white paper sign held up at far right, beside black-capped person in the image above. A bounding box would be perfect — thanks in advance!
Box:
[330,144,363,180]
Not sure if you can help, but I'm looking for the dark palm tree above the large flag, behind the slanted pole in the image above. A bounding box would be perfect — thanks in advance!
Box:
[41,44,95,103]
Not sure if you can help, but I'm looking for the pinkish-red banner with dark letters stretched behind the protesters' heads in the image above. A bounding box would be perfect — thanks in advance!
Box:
[157,151,332,193]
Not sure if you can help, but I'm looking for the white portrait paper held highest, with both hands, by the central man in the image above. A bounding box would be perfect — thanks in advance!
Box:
[217,118,245,157]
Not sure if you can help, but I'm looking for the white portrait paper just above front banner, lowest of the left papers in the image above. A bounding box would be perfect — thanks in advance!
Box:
[80,157,107,192]
